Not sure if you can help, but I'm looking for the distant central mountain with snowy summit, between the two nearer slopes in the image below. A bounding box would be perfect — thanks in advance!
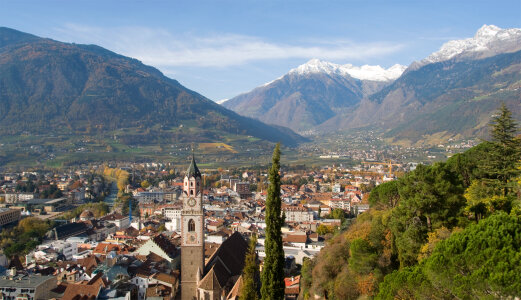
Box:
[222,59,405,132]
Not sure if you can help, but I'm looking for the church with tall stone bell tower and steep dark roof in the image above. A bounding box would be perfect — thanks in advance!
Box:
[181,155,248,300]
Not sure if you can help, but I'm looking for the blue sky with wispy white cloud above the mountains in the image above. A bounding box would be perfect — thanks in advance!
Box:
[0,0,521,101]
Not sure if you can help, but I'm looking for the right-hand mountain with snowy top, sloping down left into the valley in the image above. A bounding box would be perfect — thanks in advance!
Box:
[319,26,521,144]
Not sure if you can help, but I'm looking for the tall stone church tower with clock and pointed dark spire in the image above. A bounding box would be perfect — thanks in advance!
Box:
[181,154,204,300]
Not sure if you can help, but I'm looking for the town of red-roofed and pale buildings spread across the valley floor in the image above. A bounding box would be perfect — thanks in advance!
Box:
[0,155,406,299]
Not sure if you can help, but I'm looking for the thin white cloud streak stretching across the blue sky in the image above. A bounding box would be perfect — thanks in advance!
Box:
[50,24,404,68]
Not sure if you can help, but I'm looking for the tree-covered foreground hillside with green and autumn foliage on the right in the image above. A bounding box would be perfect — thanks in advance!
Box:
[301,107,521,299]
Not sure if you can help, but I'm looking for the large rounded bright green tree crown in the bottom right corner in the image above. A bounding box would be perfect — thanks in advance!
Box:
[424,212,521,299]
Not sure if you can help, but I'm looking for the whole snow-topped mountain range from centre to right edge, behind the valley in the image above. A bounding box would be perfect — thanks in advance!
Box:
[222,25,521,144]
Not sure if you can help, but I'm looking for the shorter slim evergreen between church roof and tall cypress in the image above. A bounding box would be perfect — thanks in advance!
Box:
[239,235,259,300]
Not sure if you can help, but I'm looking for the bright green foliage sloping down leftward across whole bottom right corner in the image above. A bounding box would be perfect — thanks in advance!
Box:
[377,212,521,299]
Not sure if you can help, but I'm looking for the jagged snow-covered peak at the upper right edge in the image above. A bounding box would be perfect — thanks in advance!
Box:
[421,25,521,64]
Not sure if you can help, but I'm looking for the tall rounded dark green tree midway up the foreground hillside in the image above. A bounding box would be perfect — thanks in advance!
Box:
[391,163,465,266]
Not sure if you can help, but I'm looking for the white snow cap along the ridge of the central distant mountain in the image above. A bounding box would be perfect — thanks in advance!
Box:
[289,58,407,81]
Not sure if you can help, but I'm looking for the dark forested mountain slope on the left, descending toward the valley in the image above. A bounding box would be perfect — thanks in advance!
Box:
[0,28,302,145]
